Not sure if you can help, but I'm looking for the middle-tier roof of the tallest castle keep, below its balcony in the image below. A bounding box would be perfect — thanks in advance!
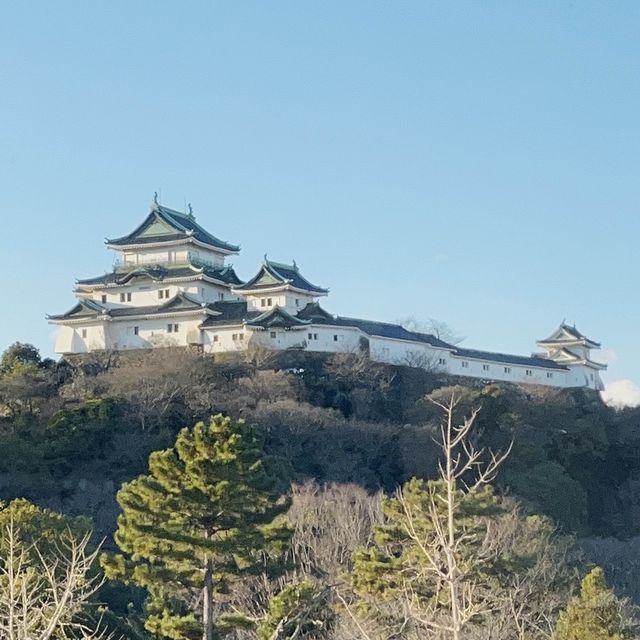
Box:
[76,260,242,287]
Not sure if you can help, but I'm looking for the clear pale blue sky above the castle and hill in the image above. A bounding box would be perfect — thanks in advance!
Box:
[0,0,640,402]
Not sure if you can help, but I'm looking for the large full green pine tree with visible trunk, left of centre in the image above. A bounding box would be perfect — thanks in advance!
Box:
[103,415,291,640]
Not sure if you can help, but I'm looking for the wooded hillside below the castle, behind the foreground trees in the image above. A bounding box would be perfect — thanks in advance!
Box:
[0,344,640,640]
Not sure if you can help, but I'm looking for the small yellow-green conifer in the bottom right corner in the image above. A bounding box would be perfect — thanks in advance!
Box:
[556,567,634,640]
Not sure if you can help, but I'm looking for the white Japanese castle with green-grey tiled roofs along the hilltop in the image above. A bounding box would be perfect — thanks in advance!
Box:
[48,198,606,390]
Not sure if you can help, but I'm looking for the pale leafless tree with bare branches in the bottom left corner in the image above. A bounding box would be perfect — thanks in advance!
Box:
[0,521,107,640]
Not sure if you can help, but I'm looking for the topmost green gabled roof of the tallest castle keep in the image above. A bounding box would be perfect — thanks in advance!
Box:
[107,199,240,253]
